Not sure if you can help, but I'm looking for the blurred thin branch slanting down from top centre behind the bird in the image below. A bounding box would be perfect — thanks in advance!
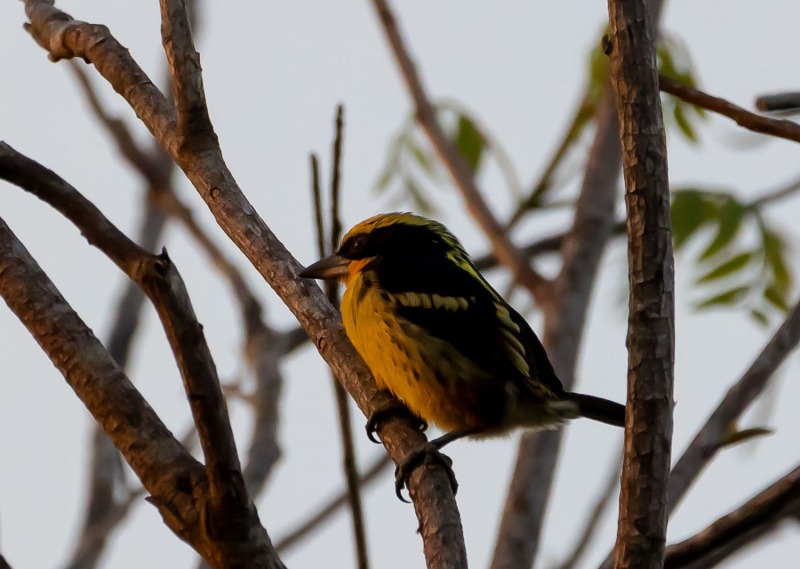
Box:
[372,0,549,302]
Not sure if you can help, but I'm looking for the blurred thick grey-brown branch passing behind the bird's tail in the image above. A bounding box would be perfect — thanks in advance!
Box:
[492,87,620,569]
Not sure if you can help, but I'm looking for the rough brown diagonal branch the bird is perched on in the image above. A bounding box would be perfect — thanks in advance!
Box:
[25,0,466,568]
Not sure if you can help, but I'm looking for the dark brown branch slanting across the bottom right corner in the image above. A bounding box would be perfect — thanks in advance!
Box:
[664,467,800,569]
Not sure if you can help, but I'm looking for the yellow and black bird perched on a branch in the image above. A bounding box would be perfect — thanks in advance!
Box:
[299,212,625,499]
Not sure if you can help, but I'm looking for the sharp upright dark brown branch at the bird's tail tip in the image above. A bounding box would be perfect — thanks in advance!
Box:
[608,0,675,569]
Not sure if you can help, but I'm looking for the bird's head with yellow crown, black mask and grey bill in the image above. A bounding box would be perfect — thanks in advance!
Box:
[300,213,466,282]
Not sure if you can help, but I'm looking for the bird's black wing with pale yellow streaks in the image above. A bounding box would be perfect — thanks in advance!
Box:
[370,256,563,394]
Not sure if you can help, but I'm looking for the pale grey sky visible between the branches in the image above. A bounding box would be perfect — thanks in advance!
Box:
[0,0,800,569]
